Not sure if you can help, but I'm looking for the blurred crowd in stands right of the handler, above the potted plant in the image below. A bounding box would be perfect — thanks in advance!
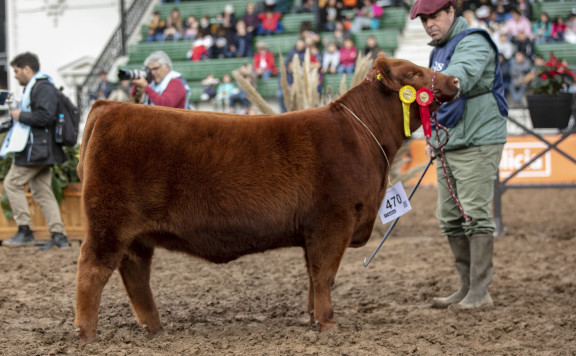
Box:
[458,0,576,108]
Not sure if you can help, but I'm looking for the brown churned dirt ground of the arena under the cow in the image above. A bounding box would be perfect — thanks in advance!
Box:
[0,188,576,356]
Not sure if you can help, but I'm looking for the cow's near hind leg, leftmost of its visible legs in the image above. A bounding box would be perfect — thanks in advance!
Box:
[74,238,121,346]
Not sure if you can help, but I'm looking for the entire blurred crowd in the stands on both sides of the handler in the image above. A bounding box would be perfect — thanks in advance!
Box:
[119,0,576,112]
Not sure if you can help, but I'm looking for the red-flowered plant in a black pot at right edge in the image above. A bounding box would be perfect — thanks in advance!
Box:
[526,53,574,129]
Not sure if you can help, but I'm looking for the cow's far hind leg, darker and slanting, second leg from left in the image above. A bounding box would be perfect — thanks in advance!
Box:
[118,242,164,338]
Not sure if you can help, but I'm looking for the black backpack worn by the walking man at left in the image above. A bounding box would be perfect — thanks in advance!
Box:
[55,88,80,146]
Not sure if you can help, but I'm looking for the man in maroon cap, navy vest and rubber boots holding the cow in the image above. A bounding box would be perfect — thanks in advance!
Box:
[410,0,508,311]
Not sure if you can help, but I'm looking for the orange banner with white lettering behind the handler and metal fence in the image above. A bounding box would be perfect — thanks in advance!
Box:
[403,135,576,186]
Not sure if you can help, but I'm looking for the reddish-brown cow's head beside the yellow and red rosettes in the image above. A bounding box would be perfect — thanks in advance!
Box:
[372,54,460,105]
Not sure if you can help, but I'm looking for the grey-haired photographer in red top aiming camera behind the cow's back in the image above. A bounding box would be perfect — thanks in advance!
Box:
[129,51,189,109]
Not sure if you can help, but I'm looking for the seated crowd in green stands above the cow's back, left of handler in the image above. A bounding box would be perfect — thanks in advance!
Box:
[141,0,404,112]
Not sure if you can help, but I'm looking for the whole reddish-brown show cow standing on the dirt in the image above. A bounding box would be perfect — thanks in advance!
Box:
[75,57,459,345]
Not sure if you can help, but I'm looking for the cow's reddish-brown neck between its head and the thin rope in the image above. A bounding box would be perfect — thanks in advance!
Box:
[334,80,405,163]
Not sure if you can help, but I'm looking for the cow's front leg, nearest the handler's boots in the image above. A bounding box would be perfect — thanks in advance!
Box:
[305,224,351,331]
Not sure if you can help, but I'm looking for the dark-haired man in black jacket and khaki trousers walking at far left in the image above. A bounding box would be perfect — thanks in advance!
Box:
[0,52,69,251]
